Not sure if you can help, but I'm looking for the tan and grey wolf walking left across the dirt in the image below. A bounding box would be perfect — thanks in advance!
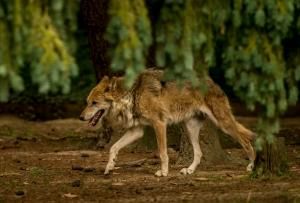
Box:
[80,69,256,176]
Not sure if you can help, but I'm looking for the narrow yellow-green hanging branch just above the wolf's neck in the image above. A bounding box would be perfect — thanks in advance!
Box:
[106,0,152,87]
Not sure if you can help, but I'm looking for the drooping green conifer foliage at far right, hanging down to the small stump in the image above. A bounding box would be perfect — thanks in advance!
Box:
[222,0,299,149]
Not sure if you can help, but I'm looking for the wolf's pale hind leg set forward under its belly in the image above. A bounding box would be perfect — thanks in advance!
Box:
[180,118,203,175]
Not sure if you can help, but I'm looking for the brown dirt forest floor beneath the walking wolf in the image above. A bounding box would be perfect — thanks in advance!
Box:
[0,116,300,203]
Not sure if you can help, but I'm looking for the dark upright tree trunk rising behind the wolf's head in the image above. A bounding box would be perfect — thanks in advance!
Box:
[80,0,112,81]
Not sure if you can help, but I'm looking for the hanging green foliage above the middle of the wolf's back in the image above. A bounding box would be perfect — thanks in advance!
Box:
[156,0,227,85]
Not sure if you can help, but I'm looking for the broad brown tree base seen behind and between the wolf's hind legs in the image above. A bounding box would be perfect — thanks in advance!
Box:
[177,119,229,164]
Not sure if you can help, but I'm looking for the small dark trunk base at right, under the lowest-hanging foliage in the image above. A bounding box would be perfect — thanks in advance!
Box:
[252,137,288,177]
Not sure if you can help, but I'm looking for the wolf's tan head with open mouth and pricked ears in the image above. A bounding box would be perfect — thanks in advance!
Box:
[80,76,126,126]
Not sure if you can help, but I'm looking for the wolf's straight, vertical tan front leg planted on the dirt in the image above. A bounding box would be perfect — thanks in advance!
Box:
[153,121,169,176]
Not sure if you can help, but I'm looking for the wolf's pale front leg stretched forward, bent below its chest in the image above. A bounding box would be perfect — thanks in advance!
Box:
[104,127,144,174]
